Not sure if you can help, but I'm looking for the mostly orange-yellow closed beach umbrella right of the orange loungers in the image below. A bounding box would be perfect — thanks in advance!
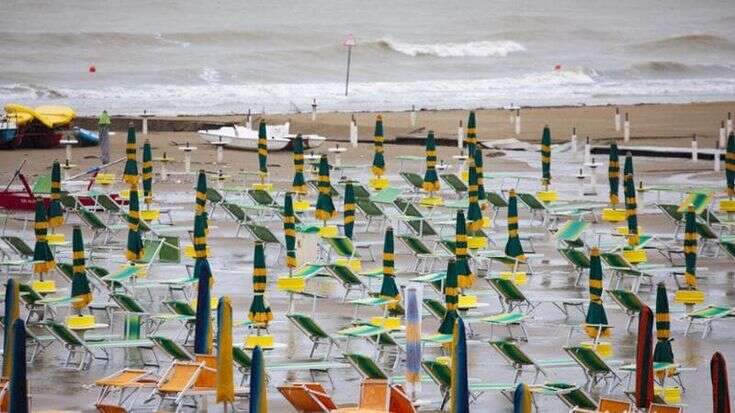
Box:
[217,296,235,403]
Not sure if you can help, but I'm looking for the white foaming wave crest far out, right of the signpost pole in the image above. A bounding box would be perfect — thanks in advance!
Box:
[377,39,526,57]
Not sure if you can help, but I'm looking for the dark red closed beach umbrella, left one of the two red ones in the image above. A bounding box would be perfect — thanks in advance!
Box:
[635,305,653,409]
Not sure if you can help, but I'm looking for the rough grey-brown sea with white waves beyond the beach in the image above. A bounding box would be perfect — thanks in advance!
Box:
[0,0,735,115]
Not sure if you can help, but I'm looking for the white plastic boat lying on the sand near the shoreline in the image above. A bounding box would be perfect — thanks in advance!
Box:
[197,122,326,151]
